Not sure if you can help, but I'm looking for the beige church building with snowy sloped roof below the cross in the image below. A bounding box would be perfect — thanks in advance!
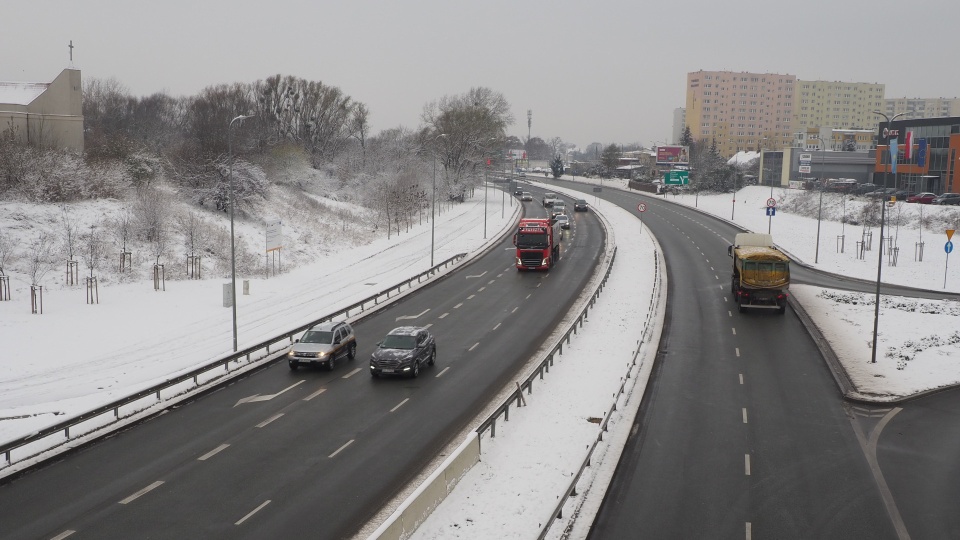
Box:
[0,69,83,152]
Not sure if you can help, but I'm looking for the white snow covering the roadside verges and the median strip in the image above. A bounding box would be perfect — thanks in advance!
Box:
[0,170,960,538]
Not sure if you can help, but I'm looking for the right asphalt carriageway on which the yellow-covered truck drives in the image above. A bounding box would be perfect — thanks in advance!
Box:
[544,184,896,538]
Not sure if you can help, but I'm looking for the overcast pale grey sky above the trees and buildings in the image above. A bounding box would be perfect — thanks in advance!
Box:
[0,0,960,146]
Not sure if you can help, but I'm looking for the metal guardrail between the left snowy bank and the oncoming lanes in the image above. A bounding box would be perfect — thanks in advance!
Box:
[0,253,467,468]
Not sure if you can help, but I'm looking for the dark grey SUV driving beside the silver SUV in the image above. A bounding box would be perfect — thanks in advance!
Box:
[370,326,437,377]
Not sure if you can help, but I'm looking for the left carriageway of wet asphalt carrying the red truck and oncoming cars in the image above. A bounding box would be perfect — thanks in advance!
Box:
[0,187,603,538]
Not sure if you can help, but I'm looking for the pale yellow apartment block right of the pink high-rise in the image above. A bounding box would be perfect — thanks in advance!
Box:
[793,80,884,132]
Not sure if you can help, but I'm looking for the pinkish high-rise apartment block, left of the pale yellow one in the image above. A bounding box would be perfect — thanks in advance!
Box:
[686,70,797,156]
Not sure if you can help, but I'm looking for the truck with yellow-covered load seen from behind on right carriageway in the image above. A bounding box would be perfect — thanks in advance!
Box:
[727,233,790,314]
